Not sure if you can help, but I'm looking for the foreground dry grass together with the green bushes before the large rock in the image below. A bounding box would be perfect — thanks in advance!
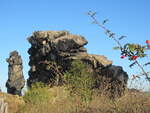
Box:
[11,61,150,113]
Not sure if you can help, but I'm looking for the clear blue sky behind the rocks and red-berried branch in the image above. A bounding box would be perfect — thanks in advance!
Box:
[0,0,150,91]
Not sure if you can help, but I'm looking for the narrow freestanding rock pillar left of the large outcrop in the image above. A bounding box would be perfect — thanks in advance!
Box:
[6,51,25,96]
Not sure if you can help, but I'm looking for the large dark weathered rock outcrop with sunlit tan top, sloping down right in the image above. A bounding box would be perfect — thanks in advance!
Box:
[28,31,128,92]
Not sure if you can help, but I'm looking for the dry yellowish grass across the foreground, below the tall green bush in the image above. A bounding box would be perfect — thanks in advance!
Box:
[14,87,150,113]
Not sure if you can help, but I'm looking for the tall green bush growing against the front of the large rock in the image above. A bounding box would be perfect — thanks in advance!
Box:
[64,60,94,102]
